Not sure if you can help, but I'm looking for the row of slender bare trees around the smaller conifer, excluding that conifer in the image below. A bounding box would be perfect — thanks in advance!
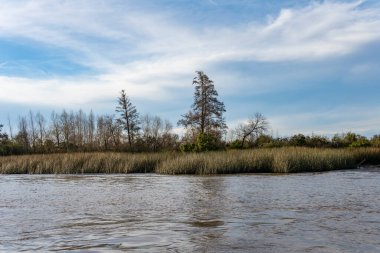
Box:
[0,110,178,155]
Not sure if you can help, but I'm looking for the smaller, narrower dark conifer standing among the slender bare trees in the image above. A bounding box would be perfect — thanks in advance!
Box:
[116,90,140,149]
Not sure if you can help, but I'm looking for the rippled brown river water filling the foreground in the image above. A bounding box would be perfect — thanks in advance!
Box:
[0,168,380,252]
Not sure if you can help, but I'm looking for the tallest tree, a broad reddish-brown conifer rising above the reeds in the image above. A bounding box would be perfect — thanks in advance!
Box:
[178,71,227,142]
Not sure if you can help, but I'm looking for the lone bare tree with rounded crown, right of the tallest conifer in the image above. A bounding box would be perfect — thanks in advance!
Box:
[236,113,269,148]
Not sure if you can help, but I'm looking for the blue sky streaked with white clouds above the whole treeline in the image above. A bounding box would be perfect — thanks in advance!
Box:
[0,0,380,136]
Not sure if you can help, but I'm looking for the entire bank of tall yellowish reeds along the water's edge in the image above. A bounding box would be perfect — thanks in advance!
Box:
[0,148,380,175]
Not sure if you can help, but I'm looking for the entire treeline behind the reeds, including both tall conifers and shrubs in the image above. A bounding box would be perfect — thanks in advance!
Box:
[0,71,380,155]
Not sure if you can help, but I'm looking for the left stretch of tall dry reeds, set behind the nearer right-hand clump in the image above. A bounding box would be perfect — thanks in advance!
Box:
[0,153,170,174]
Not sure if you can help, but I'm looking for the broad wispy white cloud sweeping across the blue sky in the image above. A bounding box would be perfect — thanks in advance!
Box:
[0,0,380,135]
